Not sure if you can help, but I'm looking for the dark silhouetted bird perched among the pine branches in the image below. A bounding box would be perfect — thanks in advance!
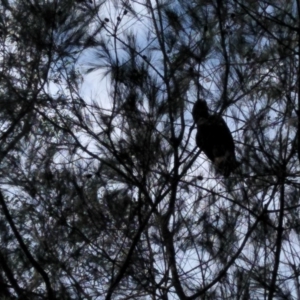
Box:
[192,99,238,177]
